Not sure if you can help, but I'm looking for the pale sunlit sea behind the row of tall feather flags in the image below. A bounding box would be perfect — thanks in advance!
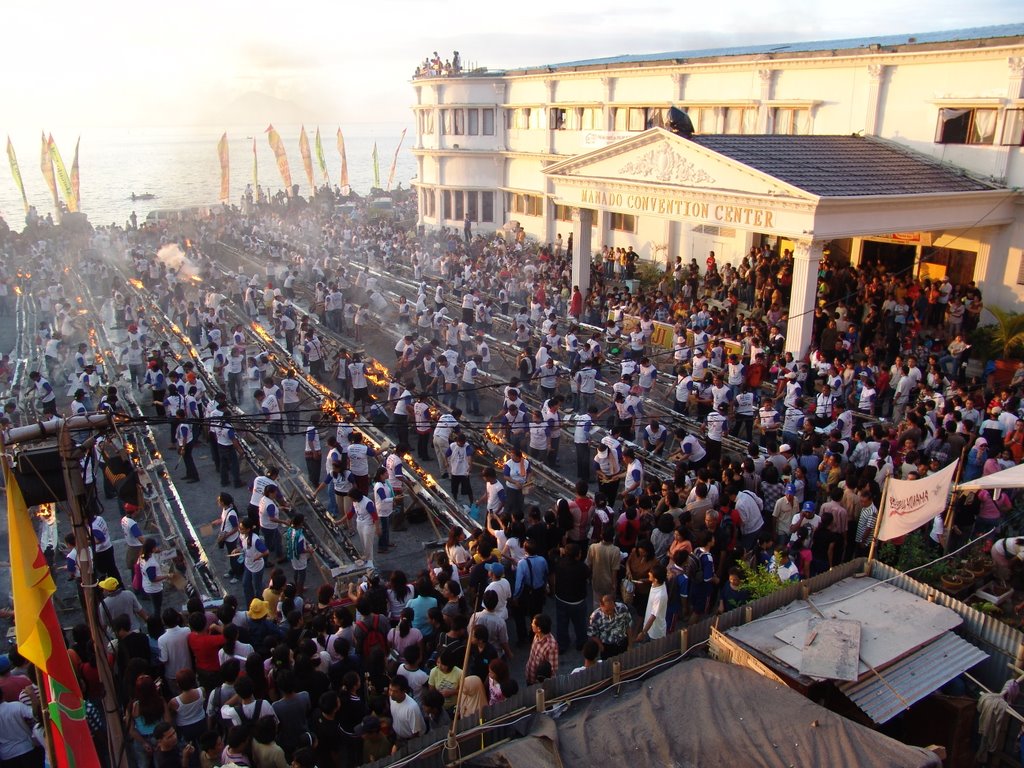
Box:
[0,122,416,231]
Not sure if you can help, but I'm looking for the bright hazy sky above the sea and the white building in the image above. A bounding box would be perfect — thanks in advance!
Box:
[0,0,1024,130]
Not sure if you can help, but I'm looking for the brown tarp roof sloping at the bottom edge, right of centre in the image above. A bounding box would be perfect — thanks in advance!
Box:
[471,659,941,768]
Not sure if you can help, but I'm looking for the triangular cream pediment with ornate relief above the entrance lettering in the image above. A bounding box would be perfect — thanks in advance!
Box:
[544,128,816,201]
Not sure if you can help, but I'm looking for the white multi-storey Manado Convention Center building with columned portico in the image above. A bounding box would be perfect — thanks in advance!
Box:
[413,24,1024,350]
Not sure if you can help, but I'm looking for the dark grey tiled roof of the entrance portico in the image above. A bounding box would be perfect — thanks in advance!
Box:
[693,134,1002,198]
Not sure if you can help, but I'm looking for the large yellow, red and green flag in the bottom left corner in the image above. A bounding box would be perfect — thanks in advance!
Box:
[4,466,99,768]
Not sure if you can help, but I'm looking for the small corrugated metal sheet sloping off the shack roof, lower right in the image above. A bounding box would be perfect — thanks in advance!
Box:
[839,632,988,723]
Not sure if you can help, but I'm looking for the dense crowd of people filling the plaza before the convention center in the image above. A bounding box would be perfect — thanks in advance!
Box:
[0,186,1024,768]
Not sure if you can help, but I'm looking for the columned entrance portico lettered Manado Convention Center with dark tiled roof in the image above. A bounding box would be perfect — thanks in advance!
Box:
[545,128,1017,356]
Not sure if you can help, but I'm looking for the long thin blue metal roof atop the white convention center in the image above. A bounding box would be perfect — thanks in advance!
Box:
[525,24,1024,69]
